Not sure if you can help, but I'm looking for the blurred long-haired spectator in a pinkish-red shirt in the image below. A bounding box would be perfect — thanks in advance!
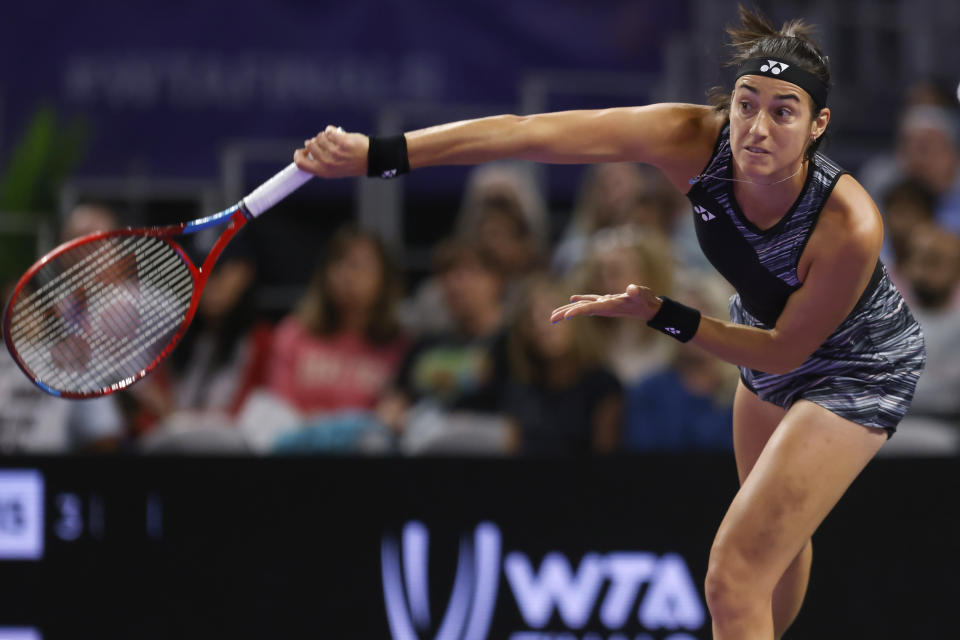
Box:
[239,226,408,453]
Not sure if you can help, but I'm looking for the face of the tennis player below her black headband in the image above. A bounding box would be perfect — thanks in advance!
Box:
[730,75,830,180]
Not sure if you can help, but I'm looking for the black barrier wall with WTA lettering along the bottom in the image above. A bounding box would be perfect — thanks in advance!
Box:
[0,456,960,640]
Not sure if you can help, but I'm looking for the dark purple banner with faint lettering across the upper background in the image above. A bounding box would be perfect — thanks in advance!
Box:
[0,0,686,177]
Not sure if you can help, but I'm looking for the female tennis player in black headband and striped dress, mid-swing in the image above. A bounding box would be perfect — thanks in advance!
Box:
[295,8,925,640]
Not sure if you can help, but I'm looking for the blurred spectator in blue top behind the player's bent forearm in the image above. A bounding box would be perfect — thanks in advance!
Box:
[623,280,738,452]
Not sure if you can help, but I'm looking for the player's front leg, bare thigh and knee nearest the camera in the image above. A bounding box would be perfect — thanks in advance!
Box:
[706,400,886,640]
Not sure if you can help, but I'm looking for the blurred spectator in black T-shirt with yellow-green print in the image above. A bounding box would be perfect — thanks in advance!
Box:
[377,239,507,453]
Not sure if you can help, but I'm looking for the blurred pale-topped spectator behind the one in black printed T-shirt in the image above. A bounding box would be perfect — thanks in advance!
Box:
[403,162,548,334]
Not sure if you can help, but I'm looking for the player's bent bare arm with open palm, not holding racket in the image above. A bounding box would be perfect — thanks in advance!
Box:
[551,176,883,374]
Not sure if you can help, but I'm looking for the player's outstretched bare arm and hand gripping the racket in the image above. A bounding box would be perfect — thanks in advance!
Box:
[295,104,722,190]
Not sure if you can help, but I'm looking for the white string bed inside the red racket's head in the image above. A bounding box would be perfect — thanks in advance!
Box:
[10,236,193,393]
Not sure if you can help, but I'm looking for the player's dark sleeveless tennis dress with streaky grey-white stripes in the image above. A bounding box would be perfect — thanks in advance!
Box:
[687,124,926,435]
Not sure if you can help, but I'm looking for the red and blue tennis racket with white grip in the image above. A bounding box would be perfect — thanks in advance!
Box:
[3,164,312,398]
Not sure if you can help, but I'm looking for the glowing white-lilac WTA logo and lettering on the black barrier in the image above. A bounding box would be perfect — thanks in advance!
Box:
[380,521,706,640]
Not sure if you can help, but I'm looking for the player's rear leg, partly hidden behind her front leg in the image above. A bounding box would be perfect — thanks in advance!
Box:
[733,382,813,638]
